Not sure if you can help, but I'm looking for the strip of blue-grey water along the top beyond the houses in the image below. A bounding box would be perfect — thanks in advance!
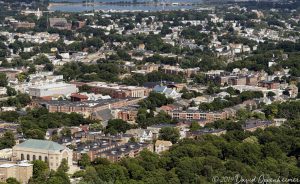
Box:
[49,0,201,12]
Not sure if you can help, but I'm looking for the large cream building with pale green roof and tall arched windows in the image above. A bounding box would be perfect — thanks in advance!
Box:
[13,139,73,170]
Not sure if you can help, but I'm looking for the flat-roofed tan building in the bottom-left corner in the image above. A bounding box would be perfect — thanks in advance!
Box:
[0,162,33,184]
